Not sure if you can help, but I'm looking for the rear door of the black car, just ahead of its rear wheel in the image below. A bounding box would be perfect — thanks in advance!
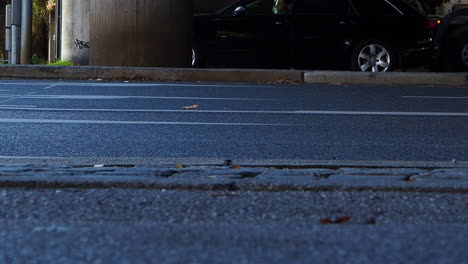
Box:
[293,0,354,69]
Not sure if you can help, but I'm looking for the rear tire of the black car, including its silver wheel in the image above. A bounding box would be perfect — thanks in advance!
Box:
[351,39,397,72]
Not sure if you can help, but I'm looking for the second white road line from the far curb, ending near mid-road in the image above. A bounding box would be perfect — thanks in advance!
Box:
[0,95,278,101]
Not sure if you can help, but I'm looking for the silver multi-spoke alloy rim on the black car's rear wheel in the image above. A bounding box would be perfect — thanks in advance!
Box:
[358,44,390,72]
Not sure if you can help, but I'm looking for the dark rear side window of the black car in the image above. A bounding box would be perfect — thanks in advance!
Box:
[294,0,349,14]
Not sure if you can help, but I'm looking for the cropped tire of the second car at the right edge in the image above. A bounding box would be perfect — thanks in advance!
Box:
[443,26,468,72]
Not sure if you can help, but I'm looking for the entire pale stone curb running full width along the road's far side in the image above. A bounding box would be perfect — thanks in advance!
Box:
[0,65,468,86]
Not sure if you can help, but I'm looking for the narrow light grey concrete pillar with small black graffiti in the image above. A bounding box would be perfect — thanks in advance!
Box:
[60,0,90,65]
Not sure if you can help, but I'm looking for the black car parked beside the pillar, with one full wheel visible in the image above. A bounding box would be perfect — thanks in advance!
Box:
[192,0,436,72]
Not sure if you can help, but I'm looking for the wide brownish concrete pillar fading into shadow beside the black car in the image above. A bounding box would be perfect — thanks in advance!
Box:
[90,0,192,67]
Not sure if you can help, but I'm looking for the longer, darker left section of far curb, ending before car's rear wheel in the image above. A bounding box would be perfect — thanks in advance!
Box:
[0,65,304,83]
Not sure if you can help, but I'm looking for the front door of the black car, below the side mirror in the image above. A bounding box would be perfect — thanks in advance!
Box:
[214,0,291,67]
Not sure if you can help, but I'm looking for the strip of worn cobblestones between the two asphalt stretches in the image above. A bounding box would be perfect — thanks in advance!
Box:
[0,165,468,194]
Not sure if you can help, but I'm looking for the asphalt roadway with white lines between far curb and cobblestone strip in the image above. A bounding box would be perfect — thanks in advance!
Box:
[0,80,468,163]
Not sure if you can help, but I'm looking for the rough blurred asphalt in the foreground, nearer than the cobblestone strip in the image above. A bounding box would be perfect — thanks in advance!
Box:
[0,189,468,264]
